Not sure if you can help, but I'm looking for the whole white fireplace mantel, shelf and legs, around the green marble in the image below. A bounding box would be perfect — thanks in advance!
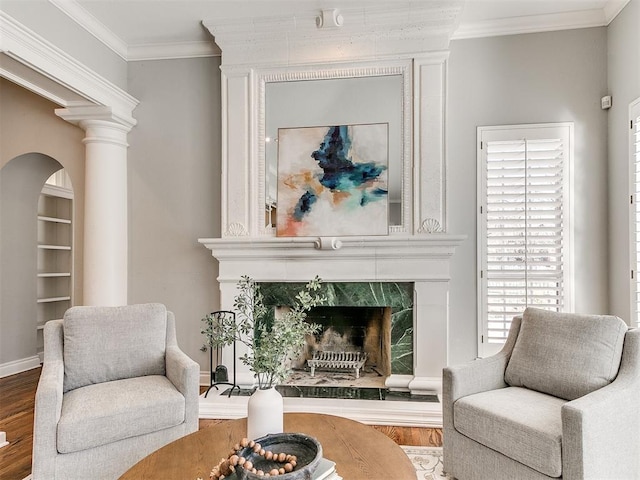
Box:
[199,233,466,394]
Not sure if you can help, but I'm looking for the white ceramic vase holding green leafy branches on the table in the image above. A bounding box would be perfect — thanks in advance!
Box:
[247,387,284,440]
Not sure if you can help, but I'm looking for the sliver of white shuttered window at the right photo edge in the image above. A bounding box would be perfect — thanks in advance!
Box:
[629,98,640,327]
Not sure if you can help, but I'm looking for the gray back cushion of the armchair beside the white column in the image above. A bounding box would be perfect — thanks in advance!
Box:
[64,304,167,392]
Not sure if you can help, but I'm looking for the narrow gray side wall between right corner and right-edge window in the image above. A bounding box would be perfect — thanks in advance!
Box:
[607,0,640,320]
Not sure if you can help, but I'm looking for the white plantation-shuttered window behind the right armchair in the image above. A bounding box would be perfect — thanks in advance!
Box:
[478,124,573,356]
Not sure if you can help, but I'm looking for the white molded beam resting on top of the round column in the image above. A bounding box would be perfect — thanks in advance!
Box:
[0,11,139,124]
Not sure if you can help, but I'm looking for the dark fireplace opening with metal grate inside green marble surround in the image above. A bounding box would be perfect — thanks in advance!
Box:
[291,306,391,381]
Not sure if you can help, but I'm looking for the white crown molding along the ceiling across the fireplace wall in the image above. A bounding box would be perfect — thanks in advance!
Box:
[49,0,630,61]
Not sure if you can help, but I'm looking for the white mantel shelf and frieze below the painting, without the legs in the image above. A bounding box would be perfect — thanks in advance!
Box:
[198,233,466,282]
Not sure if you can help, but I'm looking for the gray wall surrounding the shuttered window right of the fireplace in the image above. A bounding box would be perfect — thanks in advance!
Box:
[447,28,608,364]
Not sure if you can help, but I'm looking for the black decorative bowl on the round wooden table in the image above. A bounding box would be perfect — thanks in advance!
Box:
[236,433,322,480]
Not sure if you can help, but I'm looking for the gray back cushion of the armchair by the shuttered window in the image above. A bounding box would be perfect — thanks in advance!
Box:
[505,308,628,400]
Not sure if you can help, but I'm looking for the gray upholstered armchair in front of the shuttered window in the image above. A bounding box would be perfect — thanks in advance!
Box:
[442,308,640,480]
